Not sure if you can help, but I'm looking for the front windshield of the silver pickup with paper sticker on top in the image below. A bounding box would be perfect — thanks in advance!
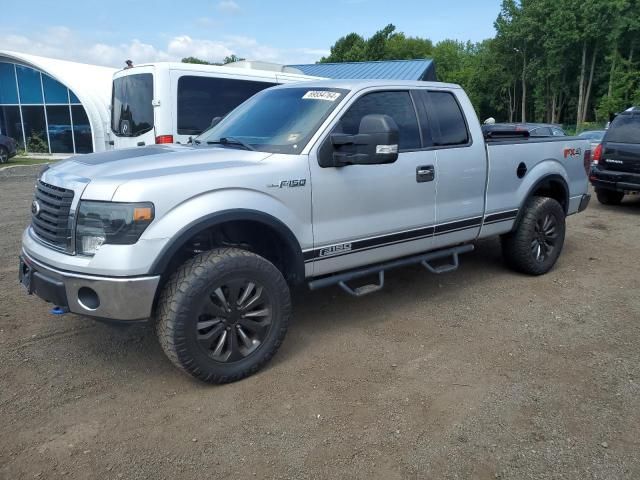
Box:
[196,87,348,154]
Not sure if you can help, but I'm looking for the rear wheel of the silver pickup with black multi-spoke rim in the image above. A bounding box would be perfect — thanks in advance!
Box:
[501,197,566,275]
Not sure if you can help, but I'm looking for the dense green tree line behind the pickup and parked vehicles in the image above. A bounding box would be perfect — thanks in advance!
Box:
[320,0,640,128]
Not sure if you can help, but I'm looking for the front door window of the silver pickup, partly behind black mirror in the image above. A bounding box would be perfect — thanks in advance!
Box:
[334,91,421,150]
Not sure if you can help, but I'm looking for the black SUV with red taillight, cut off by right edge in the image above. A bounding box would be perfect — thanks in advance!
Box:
[589,107,640,205]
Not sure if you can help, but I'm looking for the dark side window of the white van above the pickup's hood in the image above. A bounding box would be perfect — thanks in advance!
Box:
[178,76,276,135]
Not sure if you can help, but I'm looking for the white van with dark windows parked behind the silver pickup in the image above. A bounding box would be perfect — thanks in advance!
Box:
[111,62,316,148]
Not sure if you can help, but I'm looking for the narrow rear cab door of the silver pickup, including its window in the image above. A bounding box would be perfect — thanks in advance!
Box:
[421,90,487,248]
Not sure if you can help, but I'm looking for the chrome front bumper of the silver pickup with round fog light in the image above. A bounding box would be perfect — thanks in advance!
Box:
[19,250,160,321]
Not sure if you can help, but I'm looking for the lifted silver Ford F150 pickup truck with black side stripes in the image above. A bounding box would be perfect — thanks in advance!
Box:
[20,80,590,383]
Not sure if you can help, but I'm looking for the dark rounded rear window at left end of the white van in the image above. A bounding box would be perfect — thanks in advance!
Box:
[111,73,153,137]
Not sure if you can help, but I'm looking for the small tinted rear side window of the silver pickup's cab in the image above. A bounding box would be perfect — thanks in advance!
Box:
[428,91,469,146]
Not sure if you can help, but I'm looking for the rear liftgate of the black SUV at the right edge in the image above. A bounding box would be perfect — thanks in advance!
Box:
[598,112,640,173]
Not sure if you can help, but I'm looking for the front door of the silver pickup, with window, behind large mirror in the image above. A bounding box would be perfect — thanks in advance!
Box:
[305,90,436,276]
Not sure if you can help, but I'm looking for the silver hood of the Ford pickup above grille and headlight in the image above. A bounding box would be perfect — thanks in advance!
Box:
[42,145,272,200]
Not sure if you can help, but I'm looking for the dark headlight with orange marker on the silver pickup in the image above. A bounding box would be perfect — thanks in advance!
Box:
[76,201,154,255]
